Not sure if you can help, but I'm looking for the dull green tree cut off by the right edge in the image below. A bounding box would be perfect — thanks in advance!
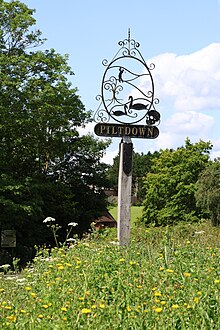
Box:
[195,159,220,226]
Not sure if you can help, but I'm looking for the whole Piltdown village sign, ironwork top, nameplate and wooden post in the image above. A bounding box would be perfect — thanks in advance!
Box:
[94,30,160,245]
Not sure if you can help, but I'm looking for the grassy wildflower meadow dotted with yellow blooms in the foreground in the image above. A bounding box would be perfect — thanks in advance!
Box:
[0,223,220,330]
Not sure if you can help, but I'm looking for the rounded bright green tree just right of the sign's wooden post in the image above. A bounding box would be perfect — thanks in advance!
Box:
[142,139,212,226]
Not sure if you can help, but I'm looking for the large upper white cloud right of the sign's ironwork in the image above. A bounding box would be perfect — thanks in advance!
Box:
[150,43,220,111]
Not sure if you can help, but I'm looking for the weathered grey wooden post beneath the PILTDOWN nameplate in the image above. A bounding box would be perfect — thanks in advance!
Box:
[118,137,133,246]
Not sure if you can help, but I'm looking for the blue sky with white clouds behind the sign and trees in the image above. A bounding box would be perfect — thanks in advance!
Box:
[22,0,220,164]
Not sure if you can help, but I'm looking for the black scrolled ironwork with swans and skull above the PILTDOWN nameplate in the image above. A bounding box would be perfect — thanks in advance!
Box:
[94,30,160,126]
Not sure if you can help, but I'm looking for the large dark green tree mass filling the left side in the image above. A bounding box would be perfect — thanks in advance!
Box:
[0,0,109,260]
